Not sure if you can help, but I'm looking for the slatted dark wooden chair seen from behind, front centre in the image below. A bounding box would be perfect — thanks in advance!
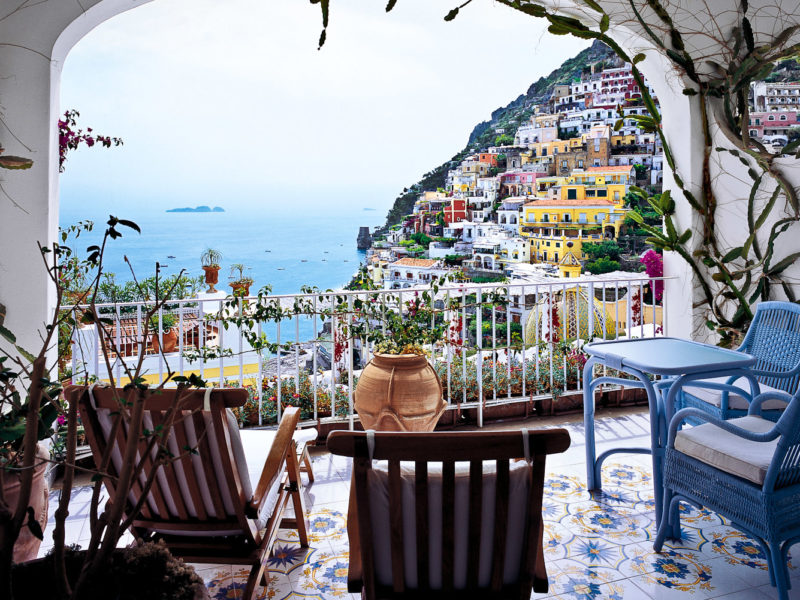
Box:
[328,429,570,600]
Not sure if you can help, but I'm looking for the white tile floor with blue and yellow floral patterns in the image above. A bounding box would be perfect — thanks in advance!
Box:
[42,412,800,600]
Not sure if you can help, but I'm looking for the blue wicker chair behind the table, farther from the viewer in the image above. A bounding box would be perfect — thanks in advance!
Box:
[675,302,800,424]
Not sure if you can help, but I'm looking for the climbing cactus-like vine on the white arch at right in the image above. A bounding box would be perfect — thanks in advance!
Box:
[312,0,800,346]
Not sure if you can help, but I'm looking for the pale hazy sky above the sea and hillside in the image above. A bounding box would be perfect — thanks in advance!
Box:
[61,0,587,210]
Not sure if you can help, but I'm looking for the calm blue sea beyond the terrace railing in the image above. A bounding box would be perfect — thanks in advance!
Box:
[59,202,386,340]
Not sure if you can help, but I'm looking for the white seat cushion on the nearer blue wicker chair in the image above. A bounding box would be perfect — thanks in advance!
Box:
[675,415,778,485]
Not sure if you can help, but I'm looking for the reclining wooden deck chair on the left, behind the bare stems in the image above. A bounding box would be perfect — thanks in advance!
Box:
[72,386,308,600]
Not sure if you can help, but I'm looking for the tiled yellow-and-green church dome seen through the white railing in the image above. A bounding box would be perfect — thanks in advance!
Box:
[525,286,617,344]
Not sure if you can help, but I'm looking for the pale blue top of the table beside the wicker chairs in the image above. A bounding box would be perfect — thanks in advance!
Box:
[583,337,756,375]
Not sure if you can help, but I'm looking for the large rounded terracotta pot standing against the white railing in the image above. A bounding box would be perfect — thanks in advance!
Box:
[354,354,446,431]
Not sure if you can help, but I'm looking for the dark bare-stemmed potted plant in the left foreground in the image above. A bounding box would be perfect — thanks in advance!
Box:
[0,217,207,599]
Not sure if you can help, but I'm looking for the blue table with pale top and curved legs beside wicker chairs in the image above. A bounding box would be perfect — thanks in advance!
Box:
[583,337,759,538]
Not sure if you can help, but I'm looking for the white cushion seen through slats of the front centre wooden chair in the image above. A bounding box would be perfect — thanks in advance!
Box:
[368,461,529,589]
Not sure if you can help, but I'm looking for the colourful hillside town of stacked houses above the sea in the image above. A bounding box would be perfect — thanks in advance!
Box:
[359,63,800,289]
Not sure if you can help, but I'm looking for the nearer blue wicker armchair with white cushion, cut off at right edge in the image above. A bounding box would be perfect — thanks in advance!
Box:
[653,392,800,600]
